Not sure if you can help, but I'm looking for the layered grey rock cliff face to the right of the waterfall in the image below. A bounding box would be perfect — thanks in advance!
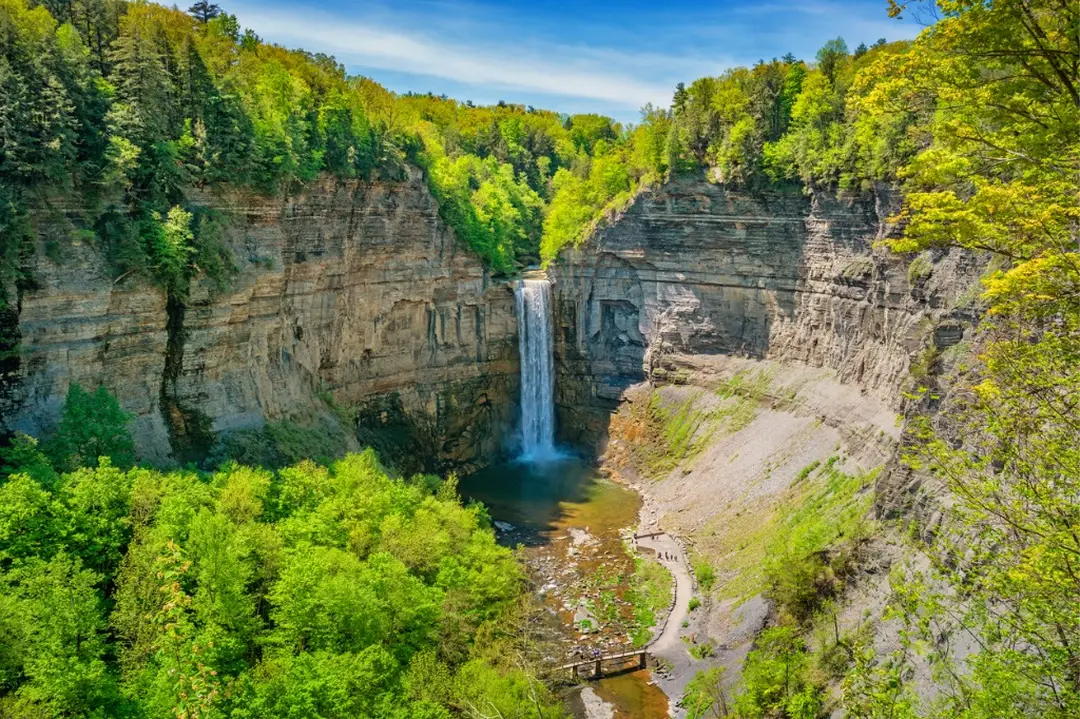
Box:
[551,173,981,443]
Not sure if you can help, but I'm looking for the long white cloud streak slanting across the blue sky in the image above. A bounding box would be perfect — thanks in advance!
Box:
[232,5,695,109]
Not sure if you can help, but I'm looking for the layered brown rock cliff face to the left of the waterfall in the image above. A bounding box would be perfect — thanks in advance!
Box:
[0,173,518,469]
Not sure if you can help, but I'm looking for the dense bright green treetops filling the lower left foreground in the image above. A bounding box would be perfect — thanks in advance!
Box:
[0,444,562,719]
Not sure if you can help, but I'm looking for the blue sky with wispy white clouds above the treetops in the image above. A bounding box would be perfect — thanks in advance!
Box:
[219,0,920,122]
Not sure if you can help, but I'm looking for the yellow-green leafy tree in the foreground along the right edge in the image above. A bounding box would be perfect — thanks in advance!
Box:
[864,0,1080,718]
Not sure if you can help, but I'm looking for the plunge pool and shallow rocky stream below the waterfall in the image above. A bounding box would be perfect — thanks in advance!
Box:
[459,457,669,719]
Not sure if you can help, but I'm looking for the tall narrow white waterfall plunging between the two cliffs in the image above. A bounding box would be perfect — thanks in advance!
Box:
[514,280,555,460]
